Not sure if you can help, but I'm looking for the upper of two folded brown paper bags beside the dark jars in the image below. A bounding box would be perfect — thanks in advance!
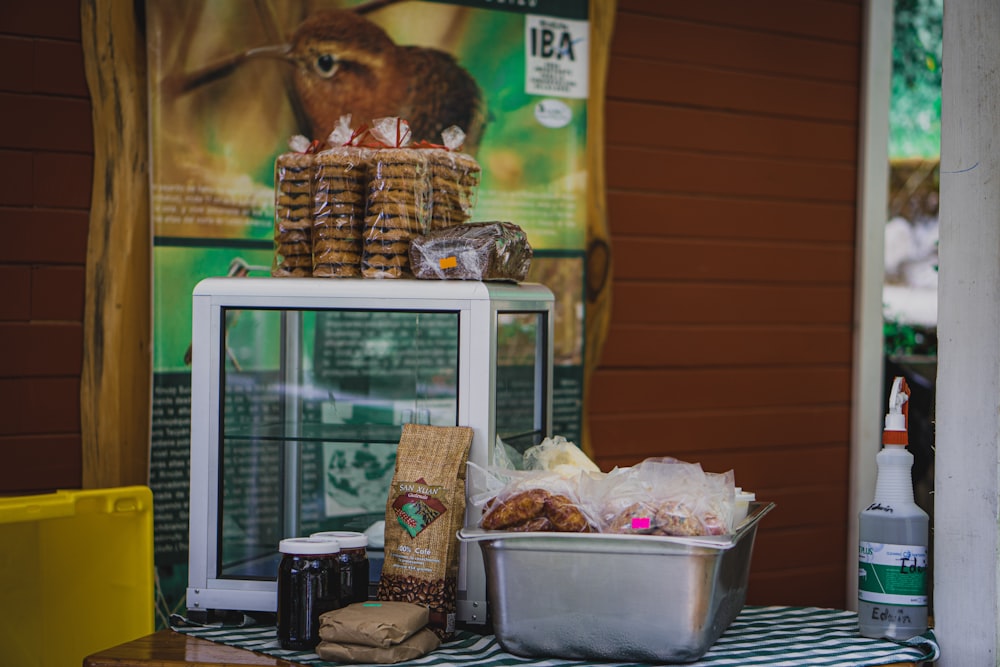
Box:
[319,600,429,648]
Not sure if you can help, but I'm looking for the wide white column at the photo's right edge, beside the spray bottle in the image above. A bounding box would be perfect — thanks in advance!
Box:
[933,0,1000,667]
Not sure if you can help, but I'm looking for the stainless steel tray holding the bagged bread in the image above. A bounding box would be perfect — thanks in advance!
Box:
[458,502,774,662]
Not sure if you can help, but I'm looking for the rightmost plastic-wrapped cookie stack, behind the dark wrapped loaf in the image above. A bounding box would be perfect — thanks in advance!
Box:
[427,126,482,229]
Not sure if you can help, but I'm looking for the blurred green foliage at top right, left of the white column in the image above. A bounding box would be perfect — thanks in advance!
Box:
[889,0,944,158]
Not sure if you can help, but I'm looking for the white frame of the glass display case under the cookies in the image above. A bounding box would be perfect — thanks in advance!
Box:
[187,277,554,623]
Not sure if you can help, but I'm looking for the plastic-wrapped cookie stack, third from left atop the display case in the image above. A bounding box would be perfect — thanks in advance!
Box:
[361,119,431,278]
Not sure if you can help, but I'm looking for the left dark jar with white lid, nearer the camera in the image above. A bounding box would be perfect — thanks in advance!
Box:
[278,537,343,650]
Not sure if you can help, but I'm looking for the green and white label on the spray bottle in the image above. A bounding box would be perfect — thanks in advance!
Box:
[858,542,927,606]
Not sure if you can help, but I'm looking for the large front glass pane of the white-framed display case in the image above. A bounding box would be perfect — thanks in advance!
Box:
[217,308,458,580]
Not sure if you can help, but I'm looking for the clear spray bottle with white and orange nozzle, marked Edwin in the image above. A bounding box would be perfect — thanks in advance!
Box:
[858,377,929,640]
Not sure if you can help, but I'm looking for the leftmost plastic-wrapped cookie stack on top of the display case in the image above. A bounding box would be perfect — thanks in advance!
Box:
[271,137,314,276]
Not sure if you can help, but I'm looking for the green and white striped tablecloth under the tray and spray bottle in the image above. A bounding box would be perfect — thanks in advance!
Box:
[174,607,940,667]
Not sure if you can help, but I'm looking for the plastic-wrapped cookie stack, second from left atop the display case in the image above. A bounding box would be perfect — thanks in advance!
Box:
[312,146,369,278]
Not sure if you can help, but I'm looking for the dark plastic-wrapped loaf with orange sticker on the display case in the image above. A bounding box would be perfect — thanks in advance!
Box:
[410,222,534,282]
